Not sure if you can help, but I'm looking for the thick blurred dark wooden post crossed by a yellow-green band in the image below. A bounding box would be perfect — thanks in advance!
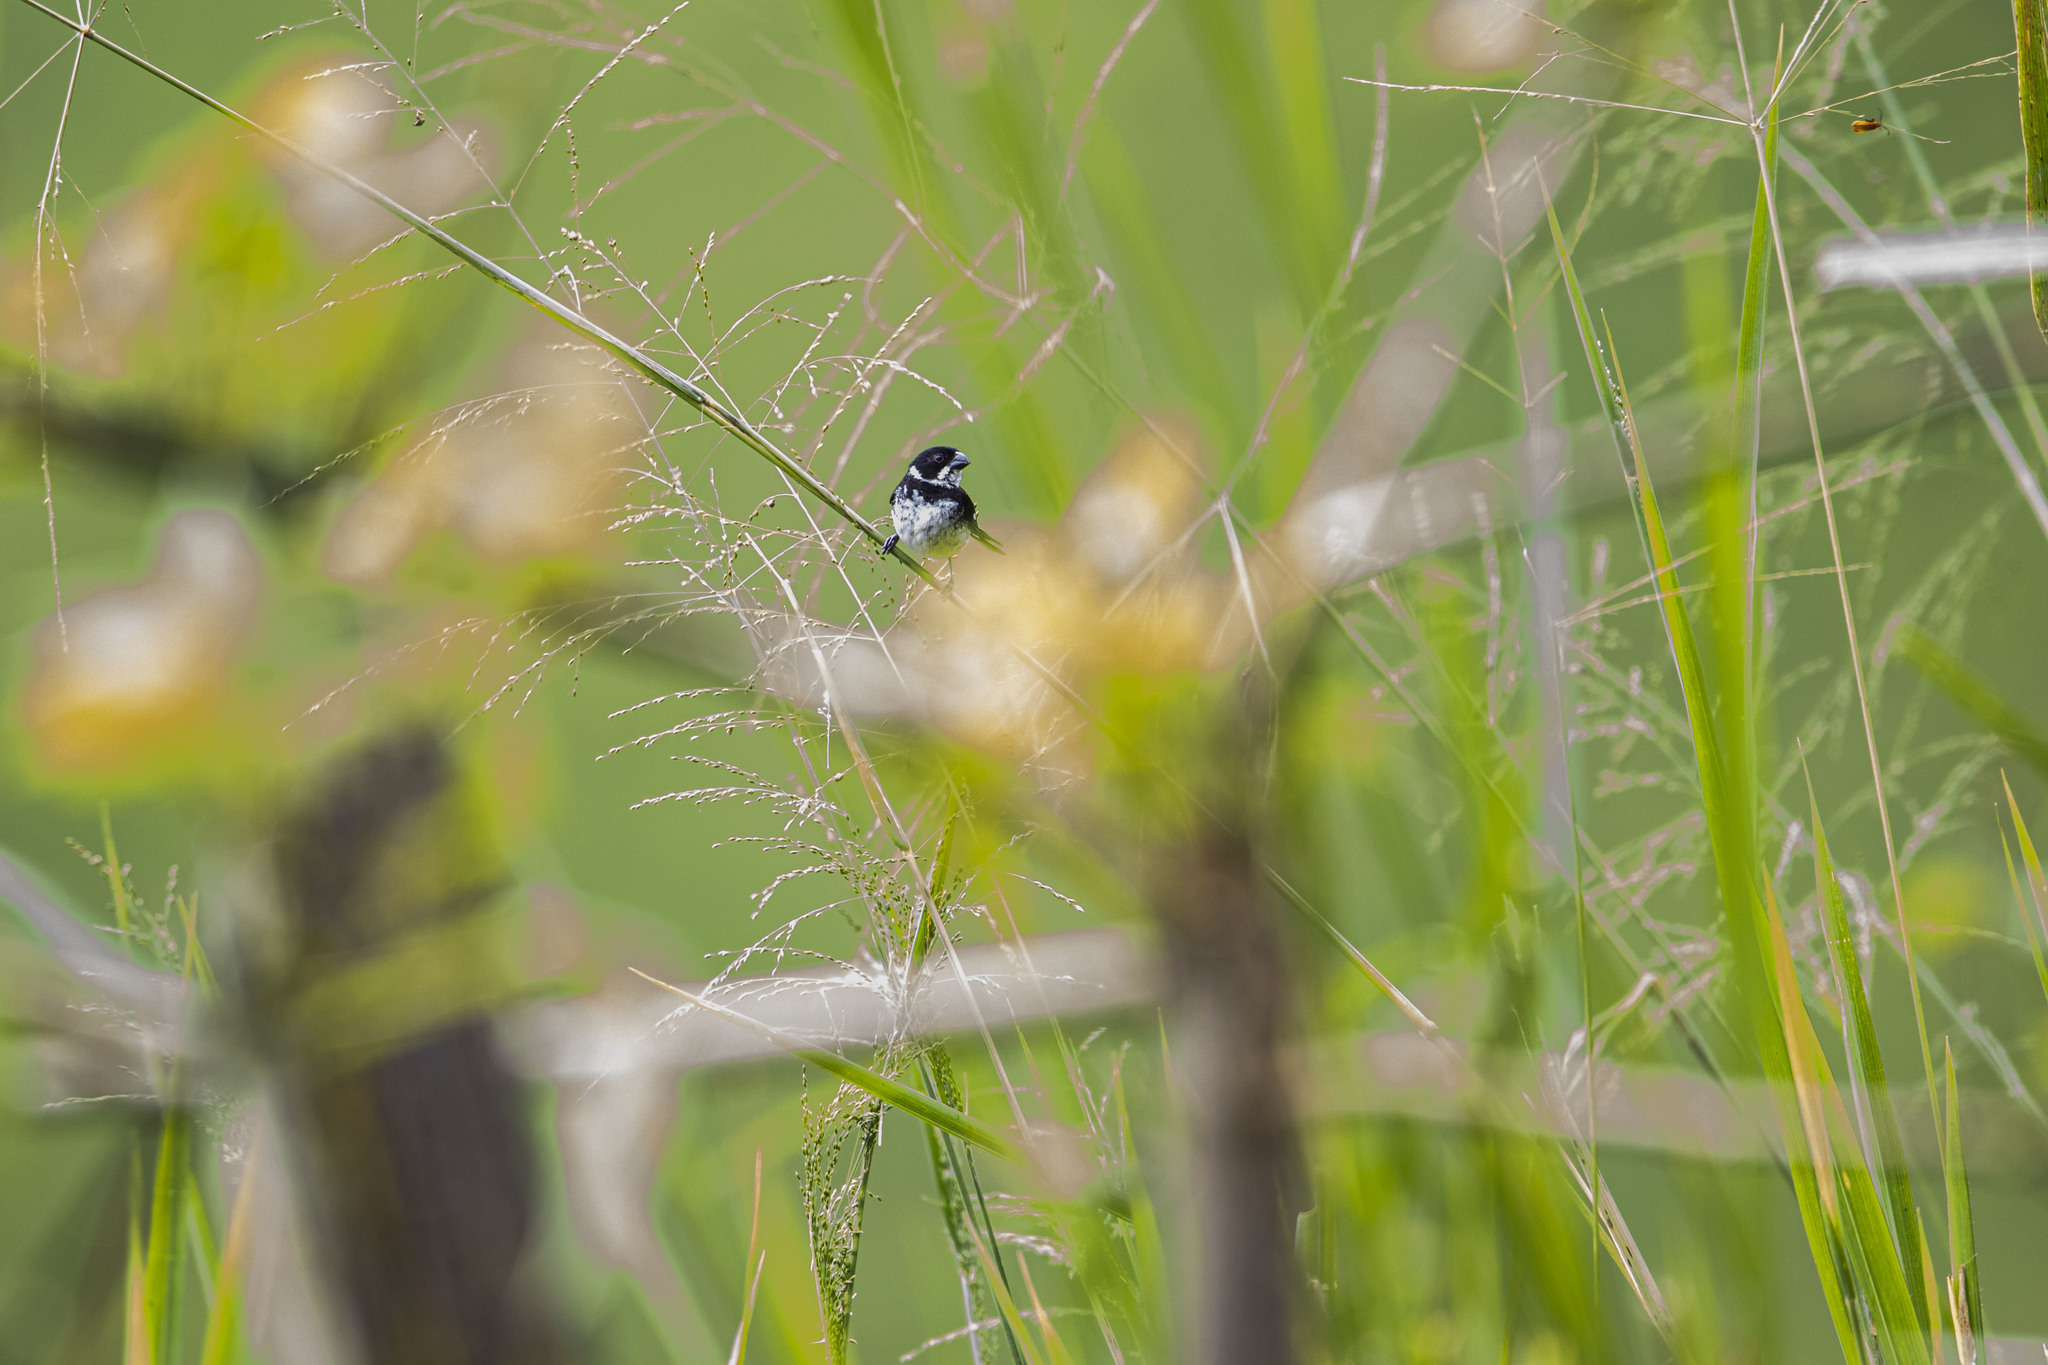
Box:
[260,729,565,1365]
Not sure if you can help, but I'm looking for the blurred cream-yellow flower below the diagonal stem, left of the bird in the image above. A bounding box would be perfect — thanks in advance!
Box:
[319,342,645,585]
